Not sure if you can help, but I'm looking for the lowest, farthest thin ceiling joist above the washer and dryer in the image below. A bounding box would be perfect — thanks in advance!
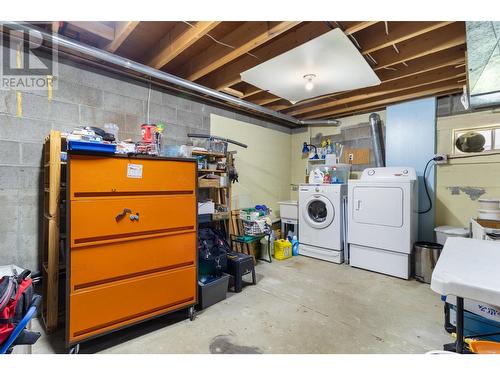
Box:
[304,78,463,120]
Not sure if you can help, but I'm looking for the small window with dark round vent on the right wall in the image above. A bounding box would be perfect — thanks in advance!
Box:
[453,125,500,154]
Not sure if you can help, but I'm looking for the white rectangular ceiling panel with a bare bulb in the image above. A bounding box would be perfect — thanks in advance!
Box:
[241,29,380,103]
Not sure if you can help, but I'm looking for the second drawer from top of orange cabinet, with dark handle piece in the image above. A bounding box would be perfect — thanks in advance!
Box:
[70,195,196,247]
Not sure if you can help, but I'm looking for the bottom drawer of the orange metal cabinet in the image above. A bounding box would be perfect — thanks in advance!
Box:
[69,267,196,342]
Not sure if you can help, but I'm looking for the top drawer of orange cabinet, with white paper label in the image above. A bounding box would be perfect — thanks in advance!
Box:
[70,155,196,199]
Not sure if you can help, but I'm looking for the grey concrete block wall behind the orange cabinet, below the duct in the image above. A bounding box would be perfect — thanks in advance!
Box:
[0,47,290,271]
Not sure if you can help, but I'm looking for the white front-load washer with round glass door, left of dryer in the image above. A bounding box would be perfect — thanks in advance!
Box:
[299,184,347,264]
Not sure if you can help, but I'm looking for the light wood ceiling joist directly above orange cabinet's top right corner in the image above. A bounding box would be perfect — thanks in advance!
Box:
[146,21,220,69]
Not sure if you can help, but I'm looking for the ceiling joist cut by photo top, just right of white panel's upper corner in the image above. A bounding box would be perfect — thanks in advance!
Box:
[356,21,453,55]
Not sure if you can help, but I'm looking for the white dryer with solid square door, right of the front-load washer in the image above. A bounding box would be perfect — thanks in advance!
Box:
[347,167,418,279]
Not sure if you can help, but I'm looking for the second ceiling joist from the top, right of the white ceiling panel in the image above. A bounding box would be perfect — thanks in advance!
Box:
[371,22,465,71]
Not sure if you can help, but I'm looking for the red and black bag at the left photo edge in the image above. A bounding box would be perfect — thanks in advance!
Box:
[0,276,33,343]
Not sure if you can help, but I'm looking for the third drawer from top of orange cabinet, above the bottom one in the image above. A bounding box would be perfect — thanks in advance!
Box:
[70,232,196,292]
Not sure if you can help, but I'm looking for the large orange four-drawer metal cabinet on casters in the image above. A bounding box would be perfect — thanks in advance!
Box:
[66,152,197,346]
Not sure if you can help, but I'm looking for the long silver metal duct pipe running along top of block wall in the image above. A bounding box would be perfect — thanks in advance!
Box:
[1,22,340,126]
